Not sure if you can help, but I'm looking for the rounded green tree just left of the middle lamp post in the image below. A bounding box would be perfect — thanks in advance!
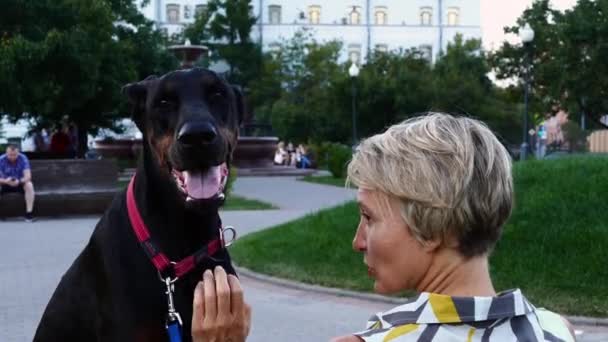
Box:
[251,30,350,142]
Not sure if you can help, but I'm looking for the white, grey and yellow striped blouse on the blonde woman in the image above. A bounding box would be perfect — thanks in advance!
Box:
[355,289,574,342]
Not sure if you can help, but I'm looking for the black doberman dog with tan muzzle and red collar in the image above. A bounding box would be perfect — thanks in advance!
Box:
[34,68,243,342]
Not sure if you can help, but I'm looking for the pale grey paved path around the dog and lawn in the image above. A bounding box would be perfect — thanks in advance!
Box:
[0,178,608,342]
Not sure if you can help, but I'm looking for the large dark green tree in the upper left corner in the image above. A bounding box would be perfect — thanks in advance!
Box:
[0,0,175,153]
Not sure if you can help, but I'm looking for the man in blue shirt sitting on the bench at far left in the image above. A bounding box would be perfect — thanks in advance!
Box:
[0,144,35,222]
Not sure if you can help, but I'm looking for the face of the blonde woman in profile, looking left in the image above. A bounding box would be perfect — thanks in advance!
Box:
[353,189,434,293]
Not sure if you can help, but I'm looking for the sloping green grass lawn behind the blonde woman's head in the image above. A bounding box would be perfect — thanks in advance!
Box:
[231,157,608,317]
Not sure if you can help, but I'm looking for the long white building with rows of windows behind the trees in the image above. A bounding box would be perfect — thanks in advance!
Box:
[141,0,481,62]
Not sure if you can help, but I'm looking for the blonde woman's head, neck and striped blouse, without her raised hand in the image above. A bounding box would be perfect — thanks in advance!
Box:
[334,114,574,342]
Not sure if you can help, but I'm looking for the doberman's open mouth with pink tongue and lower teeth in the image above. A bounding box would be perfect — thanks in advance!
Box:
[172,163,228,201]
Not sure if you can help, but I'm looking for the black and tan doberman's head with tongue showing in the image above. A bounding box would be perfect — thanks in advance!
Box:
[123,68,243,205]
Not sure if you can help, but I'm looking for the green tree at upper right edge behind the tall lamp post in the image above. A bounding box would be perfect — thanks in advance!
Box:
[491,0,608,128]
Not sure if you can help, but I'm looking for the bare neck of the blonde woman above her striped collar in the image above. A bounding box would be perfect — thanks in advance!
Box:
[416,248,496,297]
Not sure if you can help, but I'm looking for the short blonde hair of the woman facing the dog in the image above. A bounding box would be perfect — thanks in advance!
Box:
[348,113,513,257]
